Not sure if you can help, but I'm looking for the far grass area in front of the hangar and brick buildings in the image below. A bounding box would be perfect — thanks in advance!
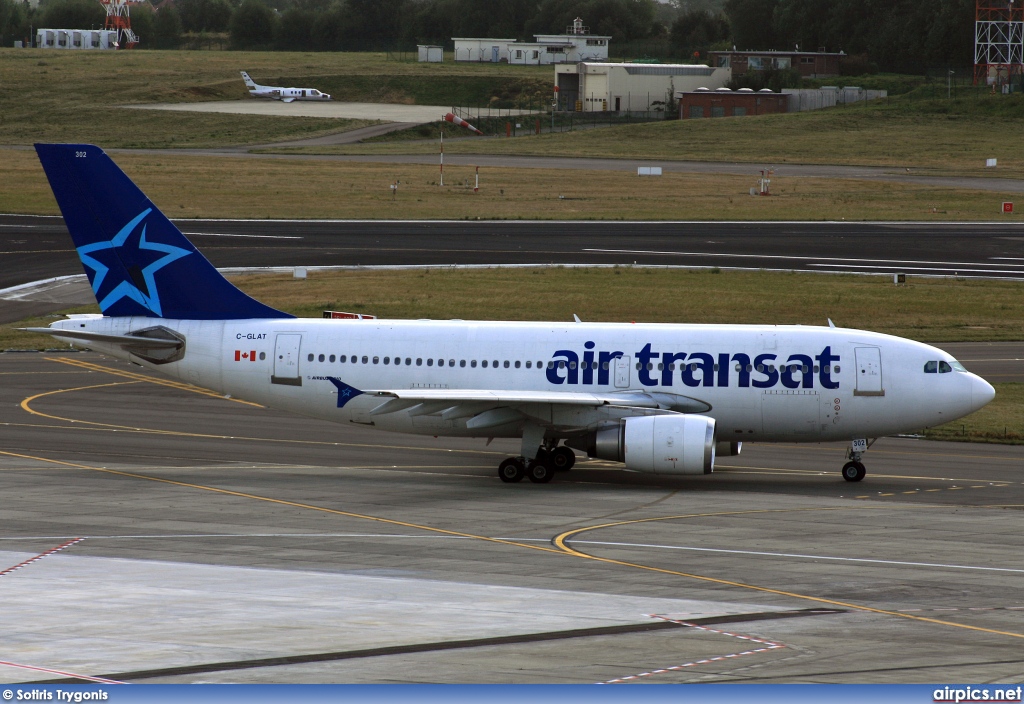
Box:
[282,94,1024,178]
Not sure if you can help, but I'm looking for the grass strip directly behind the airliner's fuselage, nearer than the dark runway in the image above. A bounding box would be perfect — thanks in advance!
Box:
[12,267,1024,442]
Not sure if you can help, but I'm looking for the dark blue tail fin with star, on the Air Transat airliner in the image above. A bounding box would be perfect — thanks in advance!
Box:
[36,144,293,320]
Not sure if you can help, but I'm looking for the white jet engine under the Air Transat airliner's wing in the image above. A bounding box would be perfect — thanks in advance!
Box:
[565,415,716,475]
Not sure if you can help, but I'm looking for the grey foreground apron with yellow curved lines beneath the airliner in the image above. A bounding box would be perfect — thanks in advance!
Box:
[0,353,1024,683]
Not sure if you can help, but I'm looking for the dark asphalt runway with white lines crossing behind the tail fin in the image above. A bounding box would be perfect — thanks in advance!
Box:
[0,215,1024,288]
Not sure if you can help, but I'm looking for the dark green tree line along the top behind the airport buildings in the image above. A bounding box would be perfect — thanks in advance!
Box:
[0,0,974,73]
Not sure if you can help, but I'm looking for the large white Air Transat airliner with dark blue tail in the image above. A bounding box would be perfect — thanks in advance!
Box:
[33,144,995,483]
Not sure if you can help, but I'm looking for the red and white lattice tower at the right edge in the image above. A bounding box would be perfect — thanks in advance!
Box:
[974,0,1024,85]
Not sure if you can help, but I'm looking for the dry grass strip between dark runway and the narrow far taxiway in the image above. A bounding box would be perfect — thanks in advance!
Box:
[6,149,1018,221]
